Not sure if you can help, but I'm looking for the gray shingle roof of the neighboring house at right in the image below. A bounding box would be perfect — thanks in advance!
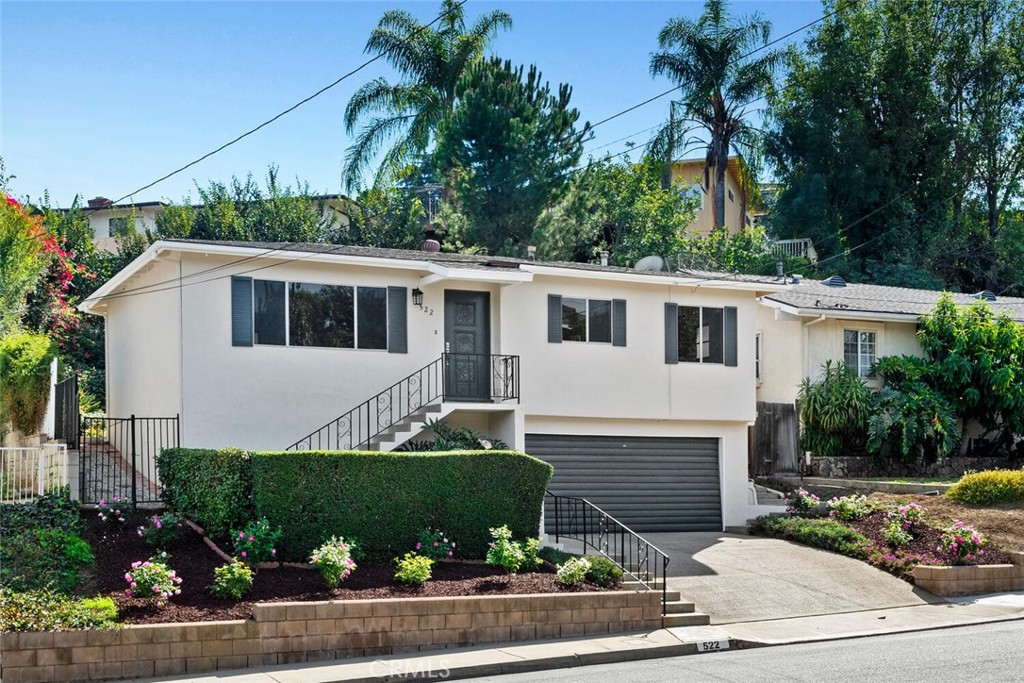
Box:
[765,280,1024,322]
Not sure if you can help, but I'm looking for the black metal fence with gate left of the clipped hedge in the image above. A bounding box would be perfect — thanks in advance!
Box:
[79,415,181,505]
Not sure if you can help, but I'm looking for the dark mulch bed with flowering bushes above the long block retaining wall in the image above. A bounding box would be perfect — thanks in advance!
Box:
[81,511,602,624]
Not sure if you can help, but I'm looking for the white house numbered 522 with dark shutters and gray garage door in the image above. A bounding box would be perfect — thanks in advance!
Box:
[81,241,785,530]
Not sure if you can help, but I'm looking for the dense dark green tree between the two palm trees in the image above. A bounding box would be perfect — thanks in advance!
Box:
[434,57,590,254]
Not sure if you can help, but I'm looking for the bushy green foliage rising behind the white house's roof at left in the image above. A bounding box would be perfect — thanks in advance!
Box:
[157,166,338,242]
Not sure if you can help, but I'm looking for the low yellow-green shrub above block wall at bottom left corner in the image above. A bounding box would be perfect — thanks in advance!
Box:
[0,589,118,632]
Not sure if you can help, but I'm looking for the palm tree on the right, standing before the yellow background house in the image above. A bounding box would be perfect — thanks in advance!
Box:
[649,0,782,228]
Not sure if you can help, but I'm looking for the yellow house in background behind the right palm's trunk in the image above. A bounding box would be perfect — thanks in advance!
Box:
[672,157,754,234]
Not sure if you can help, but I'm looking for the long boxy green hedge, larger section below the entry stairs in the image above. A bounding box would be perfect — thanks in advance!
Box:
[252,451,552,561]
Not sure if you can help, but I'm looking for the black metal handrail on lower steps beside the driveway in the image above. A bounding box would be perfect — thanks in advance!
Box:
[547,490,669,613]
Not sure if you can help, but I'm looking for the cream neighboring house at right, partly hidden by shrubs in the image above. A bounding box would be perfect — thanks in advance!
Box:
[755,276,1024,469]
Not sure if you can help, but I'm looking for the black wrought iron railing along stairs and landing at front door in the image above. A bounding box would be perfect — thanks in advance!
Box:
[286,353,519,451]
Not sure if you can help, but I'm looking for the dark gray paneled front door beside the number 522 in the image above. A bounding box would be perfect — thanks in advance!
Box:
[444,290,490,400]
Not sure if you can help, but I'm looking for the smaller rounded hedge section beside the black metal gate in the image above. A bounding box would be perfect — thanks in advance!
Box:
[157,449,254,537]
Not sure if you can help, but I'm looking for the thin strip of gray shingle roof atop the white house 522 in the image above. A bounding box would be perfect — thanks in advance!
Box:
[163,239,780,286]
